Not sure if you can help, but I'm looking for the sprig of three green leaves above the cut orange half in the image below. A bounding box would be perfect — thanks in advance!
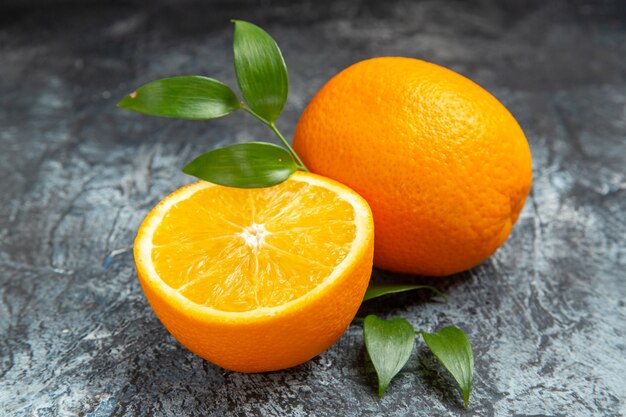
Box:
[118,20,307,188]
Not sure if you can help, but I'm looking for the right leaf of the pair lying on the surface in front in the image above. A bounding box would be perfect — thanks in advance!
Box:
[420,326,474,407]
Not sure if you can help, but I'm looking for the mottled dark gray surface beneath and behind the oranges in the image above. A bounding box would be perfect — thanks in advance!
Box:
[0,0,626,416]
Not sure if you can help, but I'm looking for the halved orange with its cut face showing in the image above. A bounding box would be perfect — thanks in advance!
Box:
[135,173,374,372]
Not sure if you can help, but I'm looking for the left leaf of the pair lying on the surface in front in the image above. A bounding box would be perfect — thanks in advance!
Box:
[363,315,415,398]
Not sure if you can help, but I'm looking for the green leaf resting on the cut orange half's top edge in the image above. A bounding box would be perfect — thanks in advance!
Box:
[183,142,298,188]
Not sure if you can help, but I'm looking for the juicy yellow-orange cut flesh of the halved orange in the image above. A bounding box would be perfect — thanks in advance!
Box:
[152,181,356,312]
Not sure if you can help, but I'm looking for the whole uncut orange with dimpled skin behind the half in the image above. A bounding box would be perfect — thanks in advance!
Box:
[294,57,532,276]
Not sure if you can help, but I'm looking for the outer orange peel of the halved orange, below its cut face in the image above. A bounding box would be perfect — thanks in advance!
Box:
[138,252,373,372]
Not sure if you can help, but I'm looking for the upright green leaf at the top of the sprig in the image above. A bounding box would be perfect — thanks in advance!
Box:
[233,20,289,123]
